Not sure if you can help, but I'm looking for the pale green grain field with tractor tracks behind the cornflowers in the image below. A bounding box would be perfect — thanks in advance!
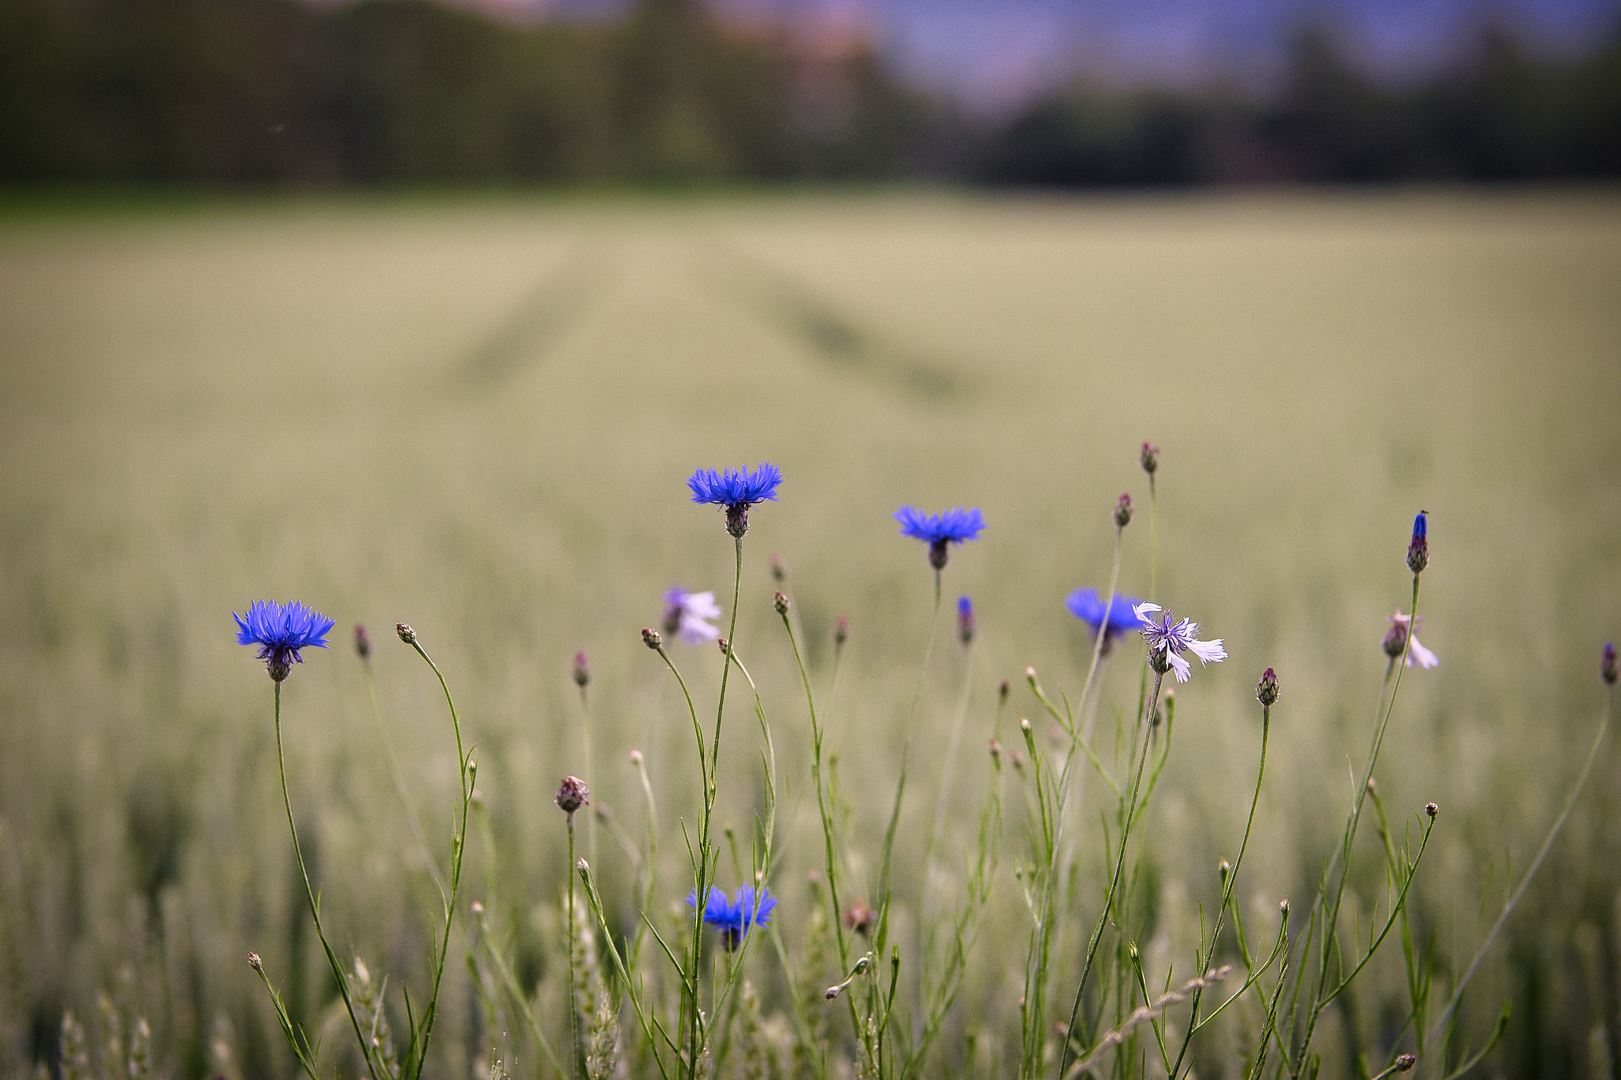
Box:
[0,193,1621,1080]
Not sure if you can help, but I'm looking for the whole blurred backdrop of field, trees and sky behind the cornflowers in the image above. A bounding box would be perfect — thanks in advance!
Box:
[0,0,1621,1080]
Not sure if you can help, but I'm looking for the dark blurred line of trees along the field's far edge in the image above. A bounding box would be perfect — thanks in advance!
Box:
[0,0,1621,186]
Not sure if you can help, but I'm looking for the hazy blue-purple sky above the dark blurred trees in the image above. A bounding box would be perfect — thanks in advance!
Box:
[528,0,1621,109]
